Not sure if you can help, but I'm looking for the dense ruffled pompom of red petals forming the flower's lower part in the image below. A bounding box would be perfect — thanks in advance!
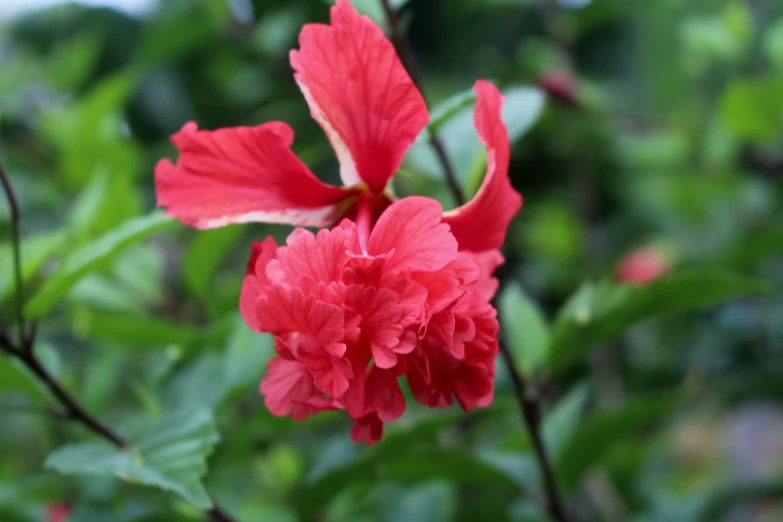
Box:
[240,197,506,443]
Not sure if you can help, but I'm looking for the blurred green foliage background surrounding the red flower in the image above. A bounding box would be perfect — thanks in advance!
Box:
[0,0,783,522]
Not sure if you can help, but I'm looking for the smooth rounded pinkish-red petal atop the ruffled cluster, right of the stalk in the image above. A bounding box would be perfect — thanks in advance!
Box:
[367,196,457,272]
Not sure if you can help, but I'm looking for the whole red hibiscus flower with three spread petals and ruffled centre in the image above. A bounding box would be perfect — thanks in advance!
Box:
[155,0,522,443]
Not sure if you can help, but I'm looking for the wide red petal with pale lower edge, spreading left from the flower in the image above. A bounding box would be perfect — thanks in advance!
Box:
[155,122,352,229]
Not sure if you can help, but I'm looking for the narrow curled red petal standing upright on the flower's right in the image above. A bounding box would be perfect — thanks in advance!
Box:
[443,80,522,252]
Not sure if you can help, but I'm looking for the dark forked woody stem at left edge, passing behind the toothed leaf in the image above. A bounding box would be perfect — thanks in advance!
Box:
[0,160,239,522]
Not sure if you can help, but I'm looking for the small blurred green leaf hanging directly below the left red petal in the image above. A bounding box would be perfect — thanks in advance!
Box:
[183,226,243,297]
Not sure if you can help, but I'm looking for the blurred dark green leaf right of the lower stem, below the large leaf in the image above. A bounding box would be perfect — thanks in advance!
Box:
[553,394,680,490]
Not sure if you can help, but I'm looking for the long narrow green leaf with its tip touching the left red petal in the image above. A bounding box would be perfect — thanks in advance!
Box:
[25,212,175,318]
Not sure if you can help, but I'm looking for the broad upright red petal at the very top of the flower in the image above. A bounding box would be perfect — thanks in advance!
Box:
[291,0,429,192]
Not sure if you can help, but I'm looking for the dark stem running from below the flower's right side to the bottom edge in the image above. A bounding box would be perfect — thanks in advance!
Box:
[500,342,569,522]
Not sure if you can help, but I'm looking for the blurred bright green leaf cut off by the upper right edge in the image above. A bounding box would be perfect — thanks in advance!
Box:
[720,78,783,142]
